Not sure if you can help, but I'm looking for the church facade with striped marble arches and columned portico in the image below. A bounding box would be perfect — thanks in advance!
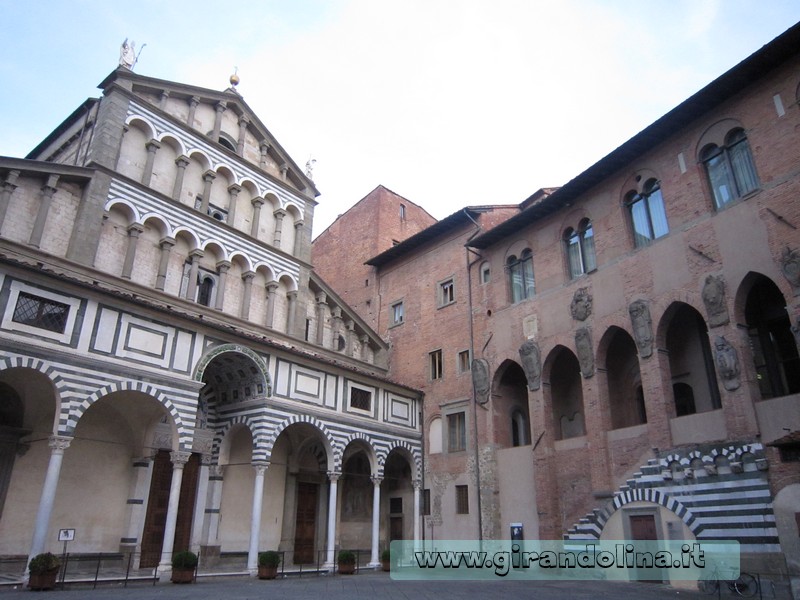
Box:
[0,66,422,571]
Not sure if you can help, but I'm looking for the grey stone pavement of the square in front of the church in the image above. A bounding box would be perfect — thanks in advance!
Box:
[0,571,716,600]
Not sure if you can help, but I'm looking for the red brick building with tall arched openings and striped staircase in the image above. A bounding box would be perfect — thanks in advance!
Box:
[312,19,800,593]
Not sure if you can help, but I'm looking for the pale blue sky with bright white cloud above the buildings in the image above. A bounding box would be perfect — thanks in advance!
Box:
[0,0,800,236]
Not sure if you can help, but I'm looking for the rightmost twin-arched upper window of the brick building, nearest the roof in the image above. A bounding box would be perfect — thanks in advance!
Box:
[700,129,759,208]
